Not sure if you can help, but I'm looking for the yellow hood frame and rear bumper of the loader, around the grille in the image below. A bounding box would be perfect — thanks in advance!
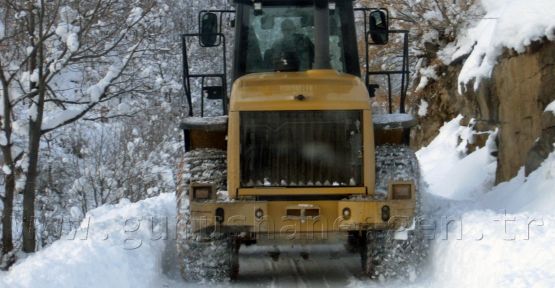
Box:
[190,70,416,236]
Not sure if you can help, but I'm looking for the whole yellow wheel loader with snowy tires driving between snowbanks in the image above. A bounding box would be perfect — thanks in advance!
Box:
[177,0,426,281]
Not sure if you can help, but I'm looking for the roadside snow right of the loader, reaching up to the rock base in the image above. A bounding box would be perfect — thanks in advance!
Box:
[416,117,555,287]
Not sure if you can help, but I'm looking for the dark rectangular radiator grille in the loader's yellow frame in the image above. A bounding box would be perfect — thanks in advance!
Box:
[241,111,362,188]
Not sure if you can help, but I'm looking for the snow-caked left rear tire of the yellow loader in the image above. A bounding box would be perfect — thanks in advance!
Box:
[176,149,239,282]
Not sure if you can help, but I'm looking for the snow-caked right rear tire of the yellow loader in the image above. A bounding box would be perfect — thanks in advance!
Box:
[360,145,429,280]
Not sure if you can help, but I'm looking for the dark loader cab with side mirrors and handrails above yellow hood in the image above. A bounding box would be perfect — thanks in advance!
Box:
[187,0,410,117]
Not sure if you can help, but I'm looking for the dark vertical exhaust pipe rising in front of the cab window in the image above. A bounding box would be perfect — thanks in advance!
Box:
[314,0,331,69]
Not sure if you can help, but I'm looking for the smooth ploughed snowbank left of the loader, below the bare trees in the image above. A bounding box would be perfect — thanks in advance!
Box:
[0,193,175,288]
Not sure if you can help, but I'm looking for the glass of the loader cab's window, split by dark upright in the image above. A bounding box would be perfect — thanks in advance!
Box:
[242,4,345,74]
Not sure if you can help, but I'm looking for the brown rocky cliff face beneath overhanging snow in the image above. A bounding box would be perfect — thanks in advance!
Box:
[410,41,555,182]
